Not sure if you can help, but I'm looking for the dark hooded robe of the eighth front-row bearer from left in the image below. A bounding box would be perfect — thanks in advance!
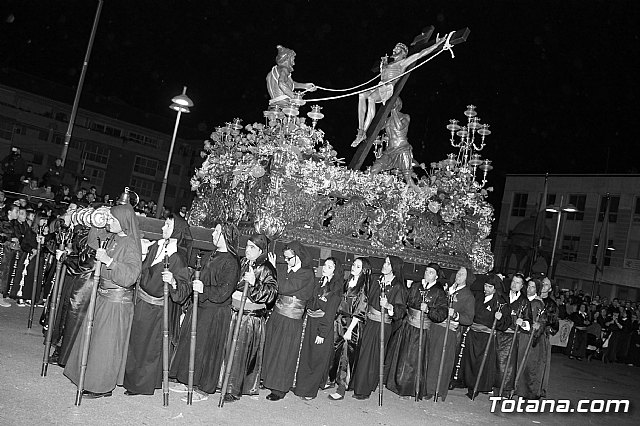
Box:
[352,277,408,396]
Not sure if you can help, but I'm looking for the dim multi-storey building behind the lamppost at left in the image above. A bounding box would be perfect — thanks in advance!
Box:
[0,76,203,209]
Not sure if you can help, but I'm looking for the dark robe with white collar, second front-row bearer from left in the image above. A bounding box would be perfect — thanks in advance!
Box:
[123,240,191,395]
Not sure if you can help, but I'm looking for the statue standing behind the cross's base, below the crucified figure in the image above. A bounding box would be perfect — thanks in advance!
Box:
[371,97,415,186]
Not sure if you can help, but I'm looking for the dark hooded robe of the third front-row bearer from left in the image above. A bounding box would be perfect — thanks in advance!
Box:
[169,252,240,393]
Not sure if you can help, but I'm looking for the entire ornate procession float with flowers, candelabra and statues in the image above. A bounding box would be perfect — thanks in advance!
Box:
[188,30,493,279]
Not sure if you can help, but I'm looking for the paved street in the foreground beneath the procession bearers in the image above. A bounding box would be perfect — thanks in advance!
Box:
[0,305,640,426]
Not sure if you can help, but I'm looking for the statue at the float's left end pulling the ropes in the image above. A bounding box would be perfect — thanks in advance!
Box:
[267,45,316,106]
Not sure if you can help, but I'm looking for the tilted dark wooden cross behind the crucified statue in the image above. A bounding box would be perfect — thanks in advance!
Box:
[349,26,471,170]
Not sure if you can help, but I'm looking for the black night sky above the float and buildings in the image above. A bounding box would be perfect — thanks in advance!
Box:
[0,0,640,204]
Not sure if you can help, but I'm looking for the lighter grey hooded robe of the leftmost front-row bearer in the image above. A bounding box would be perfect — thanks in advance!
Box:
[64,223,142,393]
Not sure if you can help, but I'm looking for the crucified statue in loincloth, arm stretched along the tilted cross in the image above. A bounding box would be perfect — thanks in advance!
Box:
[351,38,444,147]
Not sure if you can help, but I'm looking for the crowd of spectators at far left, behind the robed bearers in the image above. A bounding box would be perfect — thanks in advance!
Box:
[0,147,187,307]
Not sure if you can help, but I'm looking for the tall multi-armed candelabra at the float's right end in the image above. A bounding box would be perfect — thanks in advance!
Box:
[431,105,493,189]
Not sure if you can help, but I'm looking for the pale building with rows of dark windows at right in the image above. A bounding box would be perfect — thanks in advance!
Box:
[495,174,640,301]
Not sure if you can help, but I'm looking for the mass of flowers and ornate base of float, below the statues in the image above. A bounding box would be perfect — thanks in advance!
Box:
[189,112,493,272]
